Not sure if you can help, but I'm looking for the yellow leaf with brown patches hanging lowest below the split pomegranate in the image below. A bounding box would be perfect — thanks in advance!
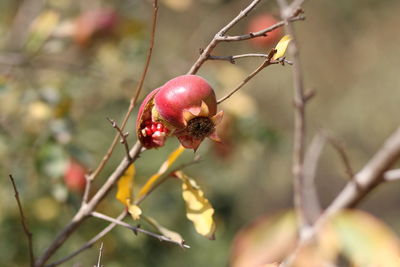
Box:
[176,172,215,240]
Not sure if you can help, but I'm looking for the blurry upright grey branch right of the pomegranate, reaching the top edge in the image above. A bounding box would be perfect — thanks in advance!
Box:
[277,0,313,238]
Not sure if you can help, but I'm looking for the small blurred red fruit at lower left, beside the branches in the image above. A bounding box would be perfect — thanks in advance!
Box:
[64,159,87,193]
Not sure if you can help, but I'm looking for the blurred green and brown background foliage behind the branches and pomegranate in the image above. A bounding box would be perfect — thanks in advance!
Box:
[0,0,400,267]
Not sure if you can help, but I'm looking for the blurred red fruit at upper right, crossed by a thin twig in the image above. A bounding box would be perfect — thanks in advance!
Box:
[248,14,283,48]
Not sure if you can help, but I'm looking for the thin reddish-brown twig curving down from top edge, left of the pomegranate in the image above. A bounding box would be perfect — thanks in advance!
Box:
[86,0,158,180]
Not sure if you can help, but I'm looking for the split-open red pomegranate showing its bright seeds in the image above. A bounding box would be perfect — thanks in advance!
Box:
[136,75,223,150]
